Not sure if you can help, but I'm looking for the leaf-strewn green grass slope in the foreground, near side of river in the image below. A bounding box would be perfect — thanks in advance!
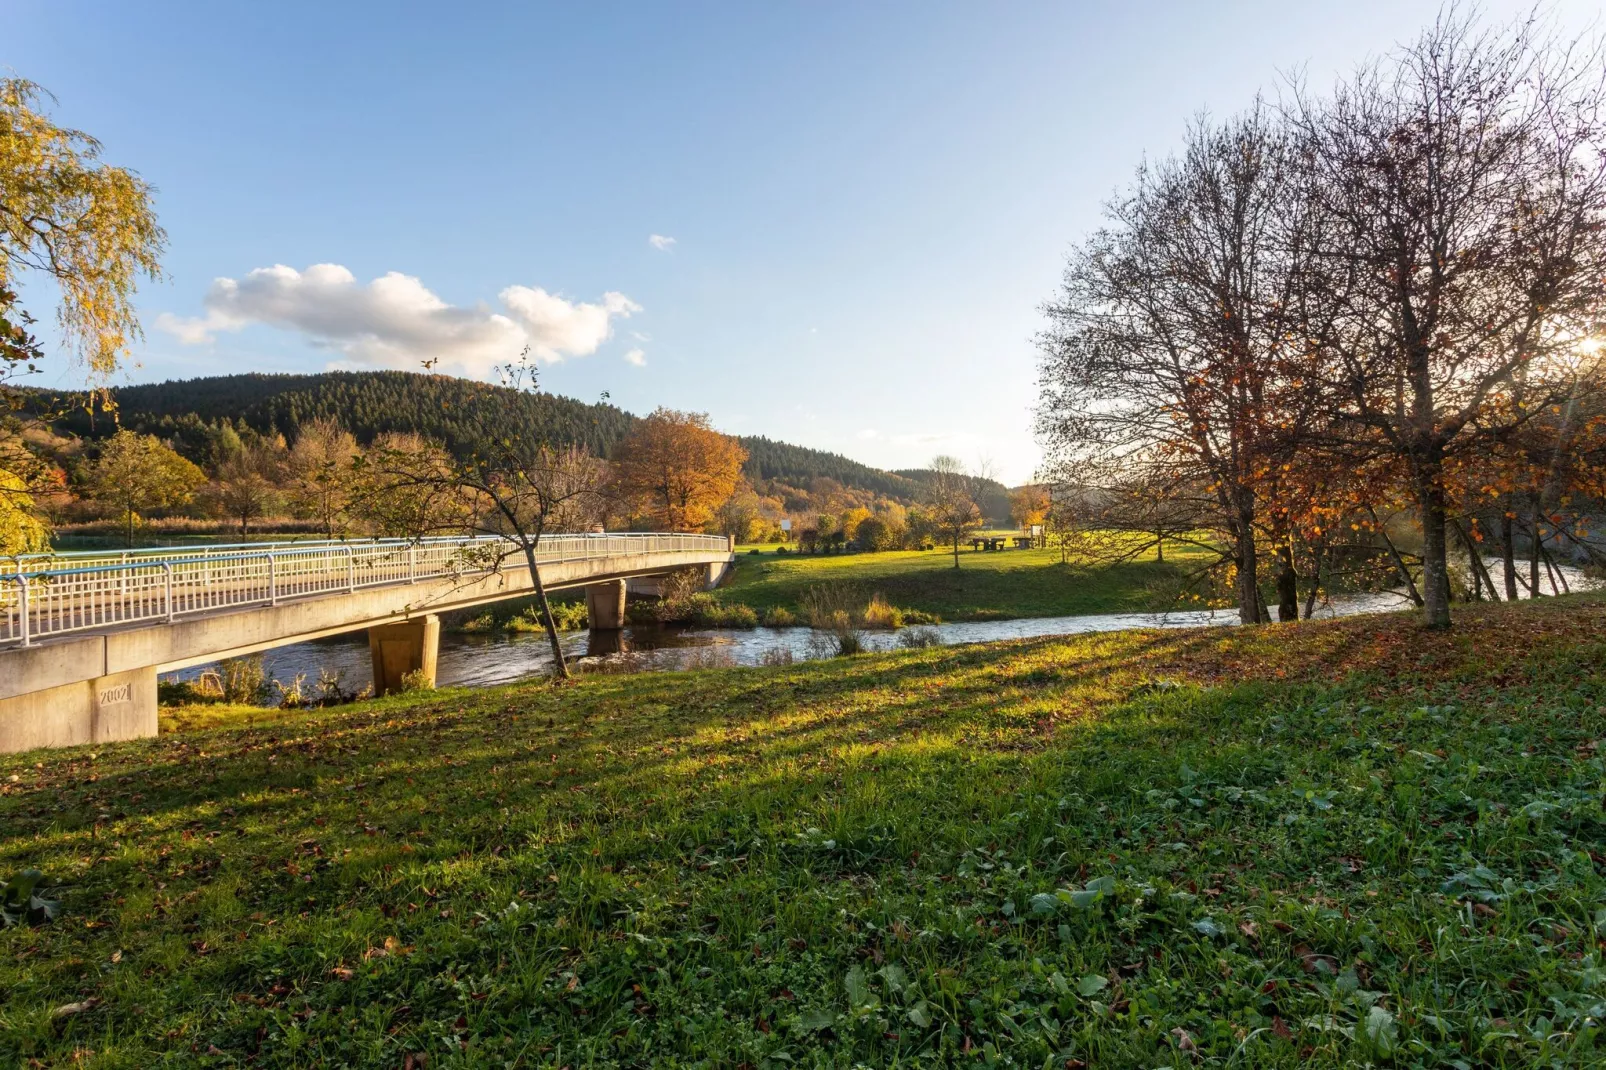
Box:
[0,598,1606,1070]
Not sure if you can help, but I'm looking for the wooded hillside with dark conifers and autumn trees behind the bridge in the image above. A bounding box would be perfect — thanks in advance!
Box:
[0,371,1029,553]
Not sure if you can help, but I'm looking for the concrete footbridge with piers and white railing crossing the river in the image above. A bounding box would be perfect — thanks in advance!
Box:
[0,535,736,753]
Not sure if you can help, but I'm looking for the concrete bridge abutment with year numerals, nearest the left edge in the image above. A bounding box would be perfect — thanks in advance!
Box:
[0,667,156,753]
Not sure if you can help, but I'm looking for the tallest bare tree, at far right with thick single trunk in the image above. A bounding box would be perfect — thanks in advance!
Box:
[1290,11,1606,627]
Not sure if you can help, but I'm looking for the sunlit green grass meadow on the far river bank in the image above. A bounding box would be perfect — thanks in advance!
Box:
[719,545,1201,620]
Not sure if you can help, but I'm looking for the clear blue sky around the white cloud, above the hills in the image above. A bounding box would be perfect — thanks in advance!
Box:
[9,0,1600,482]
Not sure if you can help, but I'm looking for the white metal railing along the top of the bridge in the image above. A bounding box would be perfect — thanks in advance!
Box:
[0,533,729,646]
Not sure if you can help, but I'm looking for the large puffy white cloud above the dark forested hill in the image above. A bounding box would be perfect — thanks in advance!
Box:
[156,263,641,376]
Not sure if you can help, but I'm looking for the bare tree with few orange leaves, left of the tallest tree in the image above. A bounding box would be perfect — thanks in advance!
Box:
[1037,104,1302,623]
